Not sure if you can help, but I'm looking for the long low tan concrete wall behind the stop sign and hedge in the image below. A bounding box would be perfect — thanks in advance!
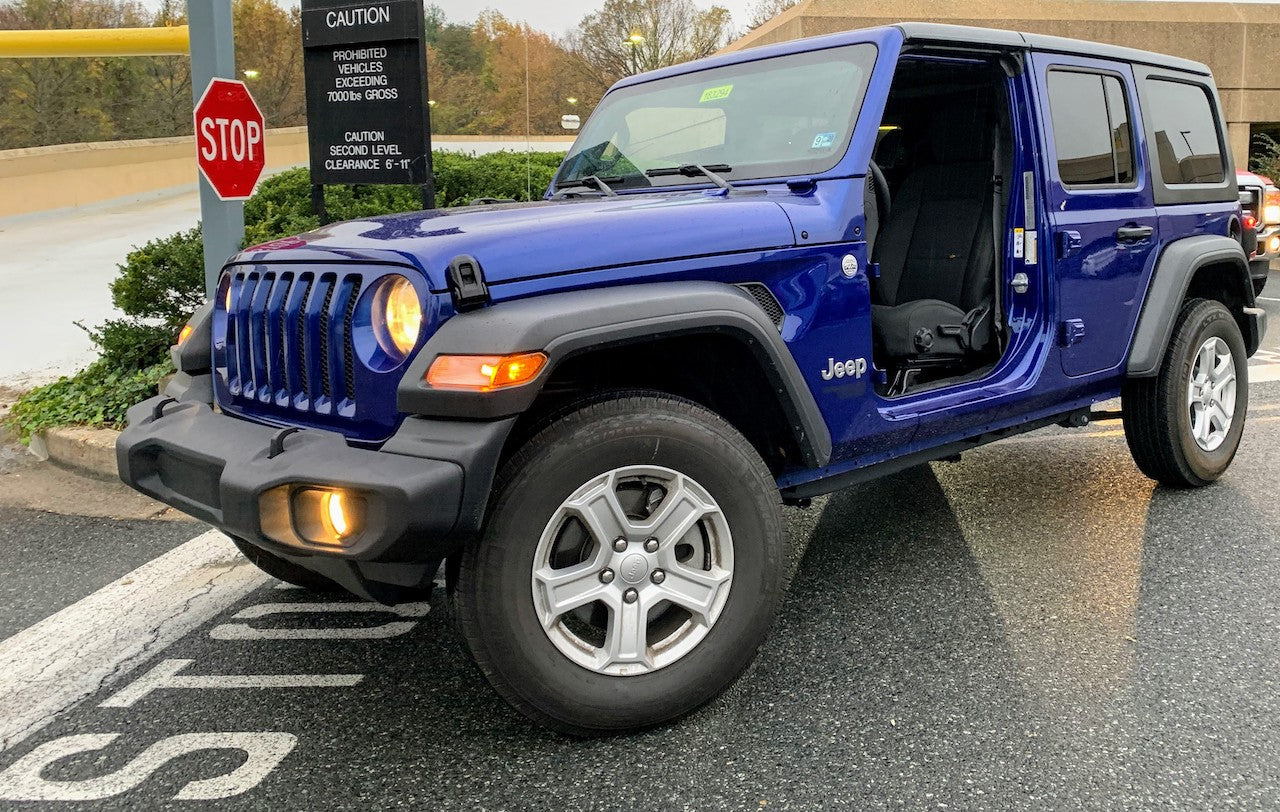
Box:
[0,127,573,216]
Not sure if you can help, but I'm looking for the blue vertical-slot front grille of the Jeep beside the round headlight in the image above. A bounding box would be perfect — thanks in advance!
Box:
[224,270,364,415]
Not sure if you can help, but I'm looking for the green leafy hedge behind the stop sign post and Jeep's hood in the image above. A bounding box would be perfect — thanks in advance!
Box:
[8,145,563,439]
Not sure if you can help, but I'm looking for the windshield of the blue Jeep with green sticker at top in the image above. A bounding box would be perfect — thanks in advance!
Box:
[556,44,876,188]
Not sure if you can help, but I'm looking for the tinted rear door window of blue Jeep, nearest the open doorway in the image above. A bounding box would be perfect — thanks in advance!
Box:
[1048,70,1134,186]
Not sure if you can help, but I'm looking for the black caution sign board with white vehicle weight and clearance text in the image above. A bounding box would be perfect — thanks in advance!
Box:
[302,0,431,186]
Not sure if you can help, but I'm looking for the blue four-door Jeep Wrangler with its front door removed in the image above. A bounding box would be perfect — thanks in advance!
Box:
[119,23,1265,734]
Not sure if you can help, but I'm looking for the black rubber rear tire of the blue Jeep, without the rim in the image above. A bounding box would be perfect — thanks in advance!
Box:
[1121,298,1249,488]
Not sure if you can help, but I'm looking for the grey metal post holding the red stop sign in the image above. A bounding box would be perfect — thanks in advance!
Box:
[187,0,244,296]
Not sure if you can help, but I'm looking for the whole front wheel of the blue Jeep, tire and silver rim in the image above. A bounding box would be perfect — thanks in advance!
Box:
[457,394,782,735]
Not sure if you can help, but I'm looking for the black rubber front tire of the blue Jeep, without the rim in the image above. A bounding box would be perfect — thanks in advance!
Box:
[454,392,783,735]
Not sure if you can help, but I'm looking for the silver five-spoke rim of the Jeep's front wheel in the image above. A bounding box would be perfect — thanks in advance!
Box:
[531,465,733,676]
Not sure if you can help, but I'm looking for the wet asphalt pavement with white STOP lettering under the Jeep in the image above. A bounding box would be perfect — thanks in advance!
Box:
[0,275,1280,809]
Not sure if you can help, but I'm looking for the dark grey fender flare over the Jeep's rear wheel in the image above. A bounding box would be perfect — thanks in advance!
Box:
[1126,234,1261,378]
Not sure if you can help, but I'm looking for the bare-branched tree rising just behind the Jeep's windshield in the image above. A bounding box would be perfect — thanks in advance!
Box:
[568,0,732,87]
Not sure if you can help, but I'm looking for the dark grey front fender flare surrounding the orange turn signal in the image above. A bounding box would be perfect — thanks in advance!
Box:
[396,282,831,467]
